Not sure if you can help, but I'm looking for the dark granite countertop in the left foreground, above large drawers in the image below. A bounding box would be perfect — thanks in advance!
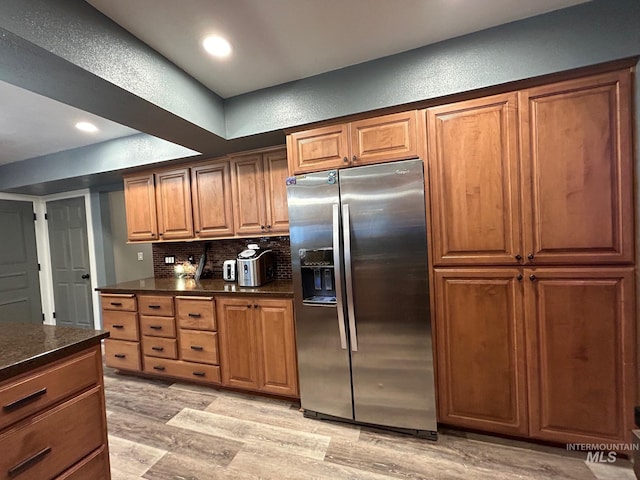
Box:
[0,323,109,382]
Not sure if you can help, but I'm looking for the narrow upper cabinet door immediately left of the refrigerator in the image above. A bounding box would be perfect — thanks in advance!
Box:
[264,149,289,233]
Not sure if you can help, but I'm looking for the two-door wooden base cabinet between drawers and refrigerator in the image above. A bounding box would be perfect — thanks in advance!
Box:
[217,297,298,396]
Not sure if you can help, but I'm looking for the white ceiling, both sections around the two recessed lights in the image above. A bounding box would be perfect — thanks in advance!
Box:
[0,0,588,169]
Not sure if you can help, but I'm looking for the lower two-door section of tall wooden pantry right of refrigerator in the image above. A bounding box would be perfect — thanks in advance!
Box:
[434,267,636,443]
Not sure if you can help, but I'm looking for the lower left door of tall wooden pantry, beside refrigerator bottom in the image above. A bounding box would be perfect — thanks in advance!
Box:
[435,268,527,435]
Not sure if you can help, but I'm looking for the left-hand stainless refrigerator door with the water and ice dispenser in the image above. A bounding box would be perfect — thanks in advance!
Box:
[287,170,353,419]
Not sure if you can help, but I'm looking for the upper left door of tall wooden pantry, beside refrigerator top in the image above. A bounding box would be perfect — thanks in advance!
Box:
[427,94,522,265]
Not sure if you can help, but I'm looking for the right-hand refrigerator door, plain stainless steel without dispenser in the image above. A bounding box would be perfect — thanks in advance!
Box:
[340,160,437,431]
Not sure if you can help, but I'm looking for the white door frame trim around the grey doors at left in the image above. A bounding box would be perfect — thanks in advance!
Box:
[0,189,101,329]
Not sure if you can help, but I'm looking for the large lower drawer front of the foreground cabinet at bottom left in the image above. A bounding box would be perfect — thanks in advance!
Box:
[0,386,107,480]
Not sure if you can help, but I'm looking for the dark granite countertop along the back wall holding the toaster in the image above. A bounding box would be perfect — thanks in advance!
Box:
[96,277,293,297]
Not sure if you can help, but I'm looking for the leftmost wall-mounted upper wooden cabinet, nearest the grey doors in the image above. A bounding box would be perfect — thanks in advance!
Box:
[124,173,158,242]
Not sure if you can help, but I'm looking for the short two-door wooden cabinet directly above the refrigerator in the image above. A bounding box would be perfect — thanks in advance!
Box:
[287,110,418,174]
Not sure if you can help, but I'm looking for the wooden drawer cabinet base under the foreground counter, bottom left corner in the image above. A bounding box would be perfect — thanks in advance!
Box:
[0,344,111,480]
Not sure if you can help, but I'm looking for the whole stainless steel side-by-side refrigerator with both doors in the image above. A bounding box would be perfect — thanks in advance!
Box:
[287,159,437,438]
